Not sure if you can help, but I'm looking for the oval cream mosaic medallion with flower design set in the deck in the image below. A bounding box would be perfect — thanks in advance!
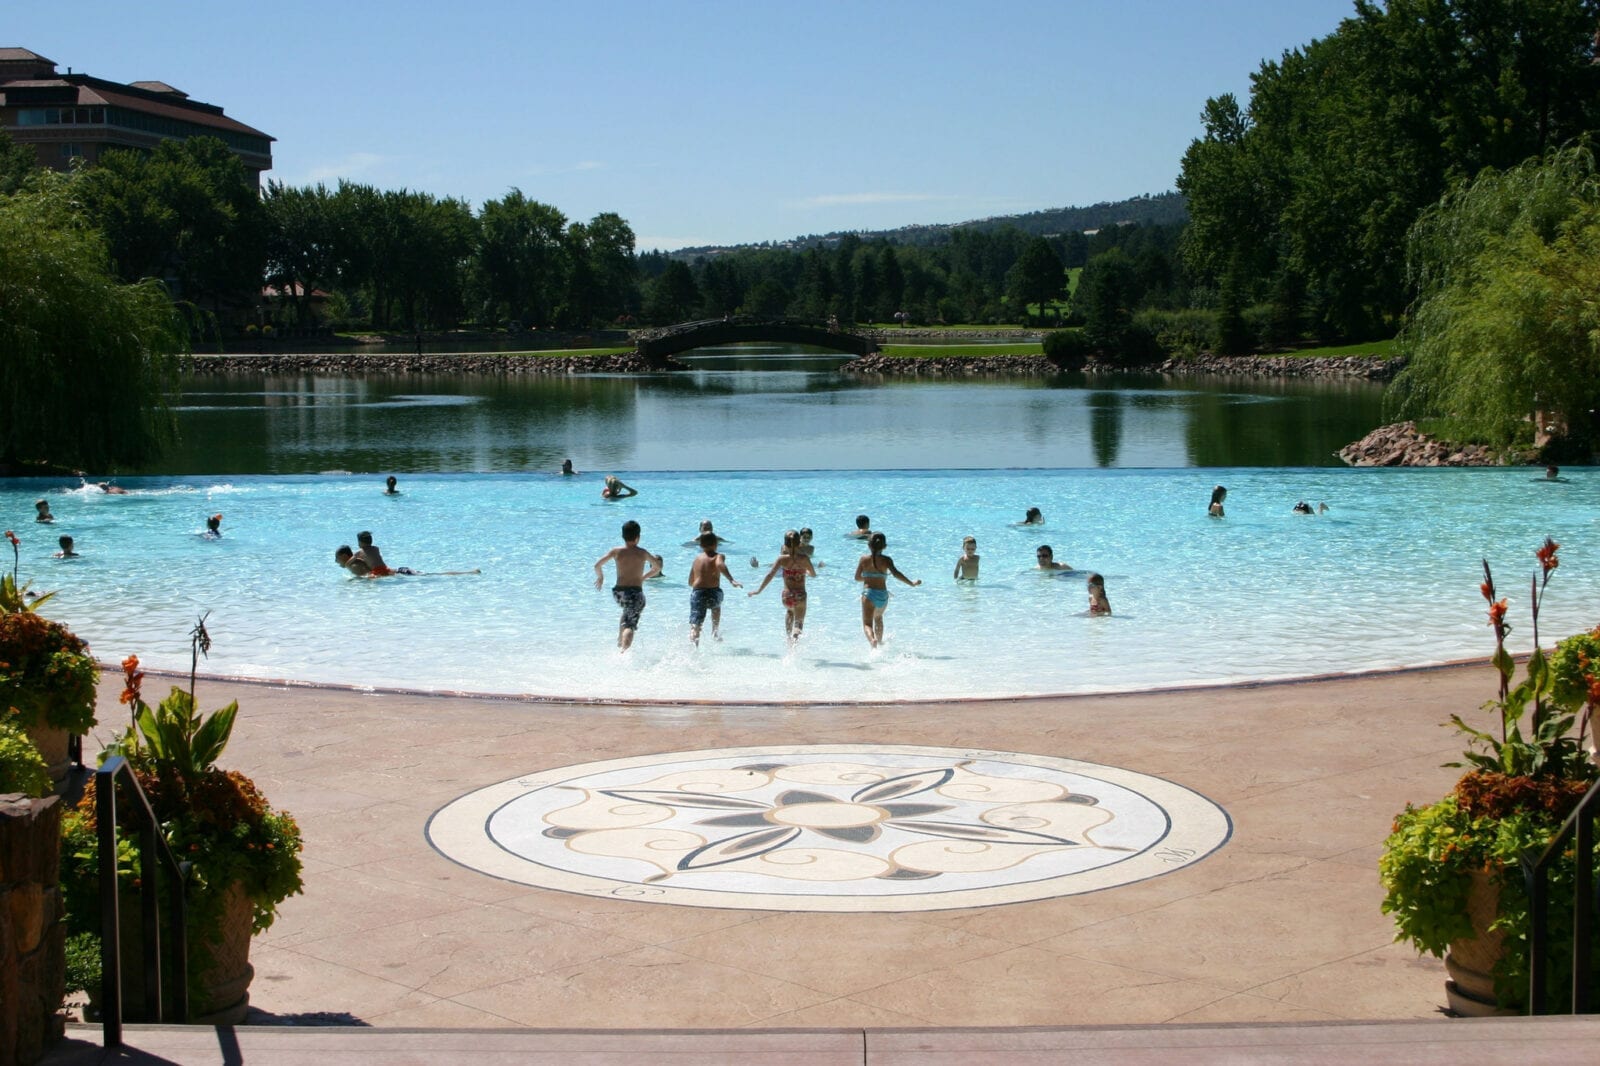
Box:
[427,744,1230,911]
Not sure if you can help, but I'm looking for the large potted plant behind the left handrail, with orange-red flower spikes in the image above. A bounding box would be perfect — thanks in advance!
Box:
[62,618,302,1024]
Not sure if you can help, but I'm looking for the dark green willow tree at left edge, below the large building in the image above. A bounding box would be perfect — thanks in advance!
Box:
[0,176,187,471]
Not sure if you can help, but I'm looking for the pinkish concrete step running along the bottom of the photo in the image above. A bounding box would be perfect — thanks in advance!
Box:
[43,1015,1600,1066]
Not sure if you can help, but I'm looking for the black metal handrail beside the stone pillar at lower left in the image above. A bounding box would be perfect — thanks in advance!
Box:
[94,755,189,1047]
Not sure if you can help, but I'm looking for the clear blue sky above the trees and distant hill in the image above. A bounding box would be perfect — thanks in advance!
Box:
[9,0,1354,250]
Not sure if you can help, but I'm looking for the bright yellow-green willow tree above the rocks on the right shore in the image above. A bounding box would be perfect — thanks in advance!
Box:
[1389,147,1600,445]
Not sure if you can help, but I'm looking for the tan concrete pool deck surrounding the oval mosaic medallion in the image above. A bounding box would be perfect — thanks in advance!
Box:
[72,663,1494,1029]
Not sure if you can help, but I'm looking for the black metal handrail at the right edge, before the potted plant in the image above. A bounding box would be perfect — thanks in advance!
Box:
[1523,781,1600,1015]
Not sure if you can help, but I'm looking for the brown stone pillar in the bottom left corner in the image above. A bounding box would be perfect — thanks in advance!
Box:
[0,794,67,1064]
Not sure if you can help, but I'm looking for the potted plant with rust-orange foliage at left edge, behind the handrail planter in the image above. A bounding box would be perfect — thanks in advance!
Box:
[0,530,99,784]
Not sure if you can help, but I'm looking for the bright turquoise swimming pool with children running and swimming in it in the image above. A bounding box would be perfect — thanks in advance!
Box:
[0,467,1600,703]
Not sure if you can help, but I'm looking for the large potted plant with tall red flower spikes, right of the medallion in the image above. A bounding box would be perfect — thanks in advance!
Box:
[1379,538,1600,1015]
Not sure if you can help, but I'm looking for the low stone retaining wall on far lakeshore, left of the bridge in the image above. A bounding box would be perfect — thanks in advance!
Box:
[189,352,650,375]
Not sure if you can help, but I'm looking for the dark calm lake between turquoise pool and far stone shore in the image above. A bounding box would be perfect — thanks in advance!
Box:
[150,351,1381,474]
